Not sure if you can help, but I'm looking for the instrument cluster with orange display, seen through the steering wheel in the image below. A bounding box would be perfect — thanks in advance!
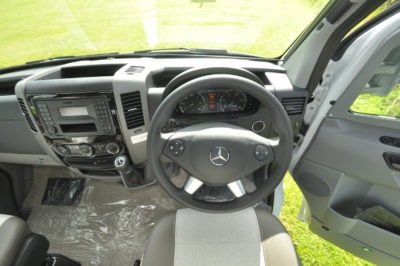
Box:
[177,88,258,115]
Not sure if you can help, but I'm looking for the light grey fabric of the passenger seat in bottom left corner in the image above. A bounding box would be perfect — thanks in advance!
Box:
[0,214,31,266]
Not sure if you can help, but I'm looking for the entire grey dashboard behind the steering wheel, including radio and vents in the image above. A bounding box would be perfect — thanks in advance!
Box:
[0,57,308,178]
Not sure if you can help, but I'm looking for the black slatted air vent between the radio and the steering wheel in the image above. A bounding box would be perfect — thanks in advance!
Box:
[121,91,144,129]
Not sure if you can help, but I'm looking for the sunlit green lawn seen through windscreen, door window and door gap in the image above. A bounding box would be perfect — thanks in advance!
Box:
[0,0,390,265]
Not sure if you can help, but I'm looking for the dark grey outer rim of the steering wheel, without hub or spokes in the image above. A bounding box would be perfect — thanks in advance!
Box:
[147,74,293,212]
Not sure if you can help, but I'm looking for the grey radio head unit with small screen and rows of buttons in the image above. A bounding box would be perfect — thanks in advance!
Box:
[34,96,116,138]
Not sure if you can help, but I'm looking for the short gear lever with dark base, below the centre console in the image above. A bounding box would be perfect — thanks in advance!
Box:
[114,155,143,188]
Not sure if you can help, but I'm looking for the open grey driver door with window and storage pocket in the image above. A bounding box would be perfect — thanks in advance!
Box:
[290,7,400,265]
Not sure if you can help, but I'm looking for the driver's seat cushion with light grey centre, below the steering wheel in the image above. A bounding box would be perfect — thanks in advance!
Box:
[142,209,301,266]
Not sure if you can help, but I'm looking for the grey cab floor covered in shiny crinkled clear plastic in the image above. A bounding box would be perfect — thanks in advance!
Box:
[24,167,181,266]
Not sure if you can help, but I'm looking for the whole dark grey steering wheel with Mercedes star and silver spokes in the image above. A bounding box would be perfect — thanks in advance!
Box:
[147,70,293,212]
